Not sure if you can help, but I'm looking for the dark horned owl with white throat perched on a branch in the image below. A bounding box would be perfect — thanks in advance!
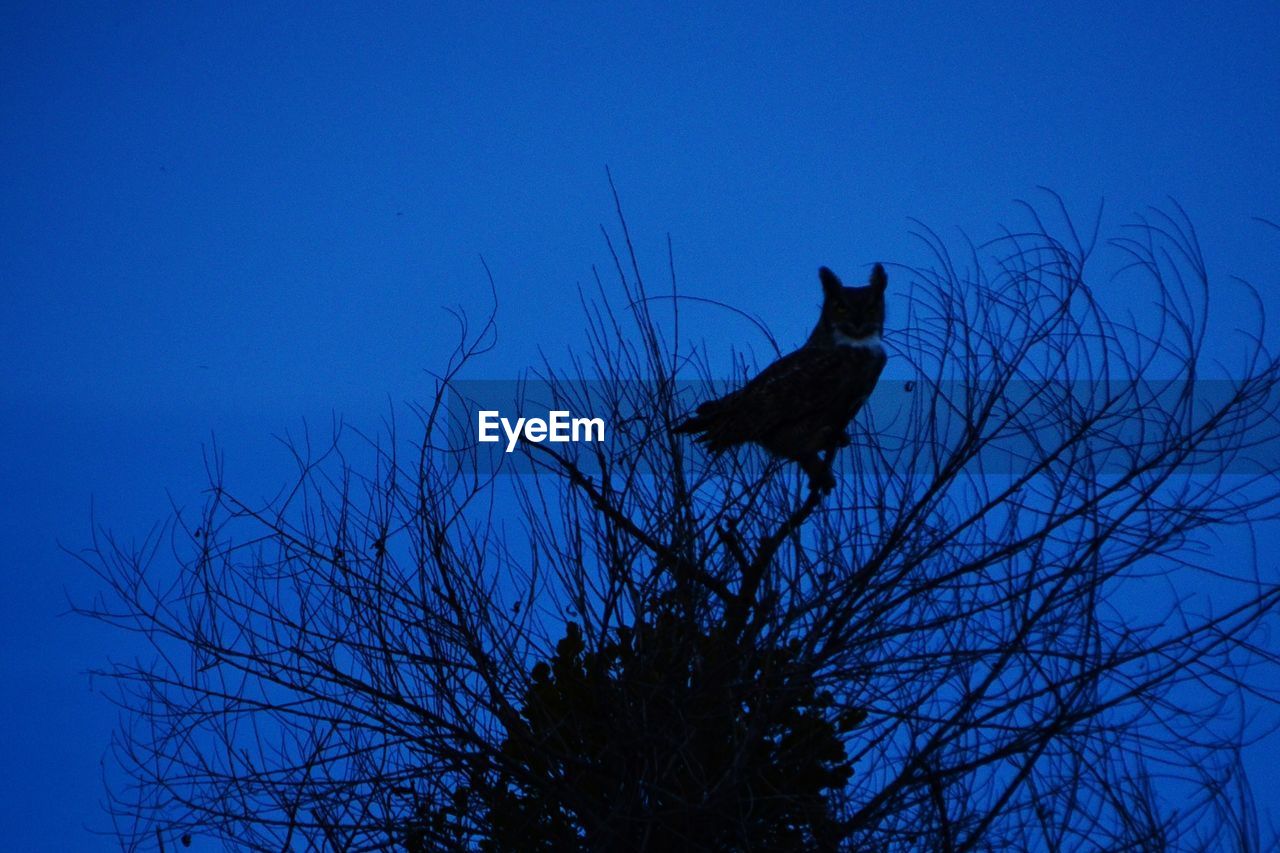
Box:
[672,264,888,492]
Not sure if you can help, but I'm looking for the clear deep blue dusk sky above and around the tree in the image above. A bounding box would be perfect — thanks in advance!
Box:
[0,0,1280,850]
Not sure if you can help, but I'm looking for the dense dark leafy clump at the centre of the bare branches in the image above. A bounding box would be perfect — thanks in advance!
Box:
[417,612,864,850]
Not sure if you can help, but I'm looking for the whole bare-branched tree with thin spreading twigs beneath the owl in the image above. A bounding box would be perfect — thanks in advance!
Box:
[82,194,1280,850]
